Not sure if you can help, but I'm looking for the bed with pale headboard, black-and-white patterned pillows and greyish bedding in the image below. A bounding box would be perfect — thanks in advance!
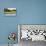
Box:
[18,24,46,46]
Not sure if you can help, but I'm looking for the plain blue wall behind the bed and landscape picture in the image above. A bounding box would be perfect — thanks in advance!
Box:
[0,0,46,44]
